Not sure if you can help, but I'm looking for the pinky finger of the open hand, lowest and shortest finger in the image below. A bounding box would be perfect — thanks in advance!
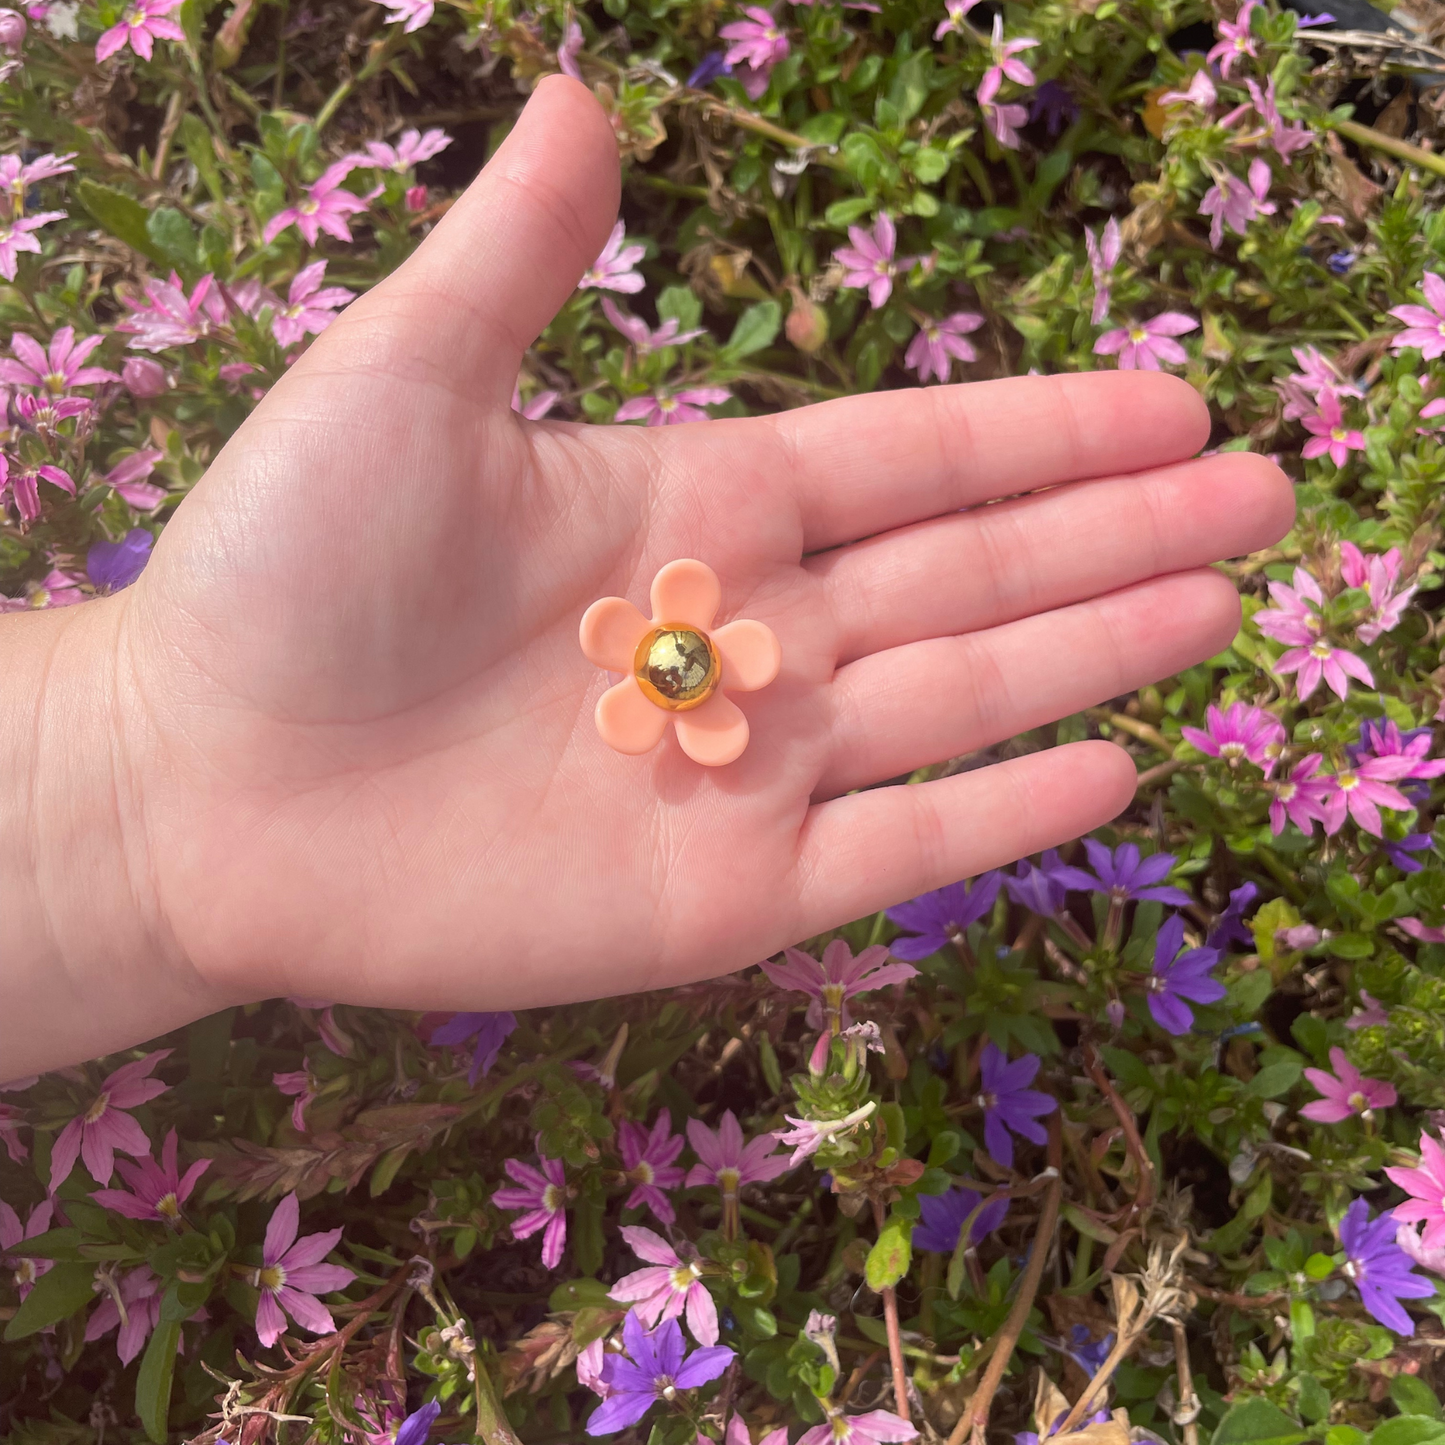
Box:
[796,743,1136,938]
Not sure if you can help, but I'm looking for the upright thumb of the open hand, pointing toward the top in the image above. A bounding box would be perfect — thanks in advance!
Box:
[351,75,620,397]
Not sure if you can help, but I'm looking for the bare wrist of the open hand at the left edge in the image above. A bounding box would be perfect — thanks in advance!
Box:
[0,597,227,1082]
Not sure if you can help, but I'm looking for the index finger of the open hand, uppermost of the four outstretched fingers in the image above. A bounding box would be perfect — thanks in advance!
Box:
[766,371,1209,552]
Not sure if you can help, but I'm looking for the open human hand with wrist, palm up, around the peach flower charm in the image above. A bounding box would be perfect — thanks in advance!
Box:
[0,78,1293,1077]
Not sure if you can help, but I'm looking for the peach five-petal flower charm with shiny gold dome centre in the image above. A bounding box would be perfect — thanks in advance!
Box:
[581,558,783,767]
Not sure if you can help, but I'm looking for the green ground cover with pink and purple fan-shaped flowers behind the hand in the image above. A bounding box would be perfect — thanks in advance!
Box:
[0,0,1445,1445]
